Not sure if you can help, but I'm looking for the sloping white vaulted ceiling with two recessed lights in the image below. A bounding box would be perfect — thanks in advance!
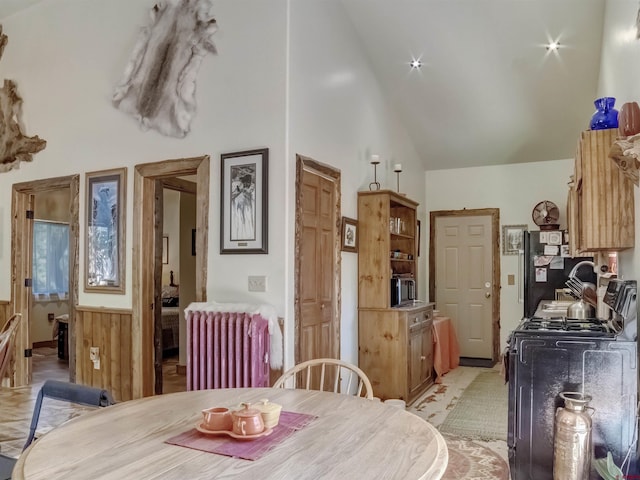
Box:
[0,0,608,170]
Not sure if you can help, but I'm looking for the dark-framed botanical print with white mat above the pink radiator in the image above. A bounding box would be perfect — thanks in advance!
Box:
[220,148,269,254]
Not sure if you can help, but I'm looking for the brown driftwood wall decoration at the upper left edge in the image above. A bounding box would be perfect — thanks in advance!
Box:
[0,25,47,172]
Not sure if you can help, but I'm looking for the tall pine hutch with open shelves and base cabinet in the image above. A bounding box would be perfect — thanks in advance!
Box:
[358,190,434,402]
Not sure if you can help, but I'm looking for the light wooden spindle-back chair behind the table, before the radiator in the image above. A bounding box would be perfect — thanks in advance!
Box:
[273,358,373,400]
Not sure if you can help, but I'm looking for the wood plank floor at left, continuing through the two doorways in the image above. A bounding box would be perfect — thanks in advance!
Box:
[0,347,186,457]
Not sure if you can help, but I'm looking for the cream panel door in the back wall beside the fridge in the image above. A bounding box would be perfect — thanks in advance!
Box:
[435,216,494,358]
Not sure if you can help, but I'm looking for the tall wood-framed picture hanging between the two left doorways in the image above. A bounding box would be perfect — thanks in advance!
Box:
[84,168,127,293]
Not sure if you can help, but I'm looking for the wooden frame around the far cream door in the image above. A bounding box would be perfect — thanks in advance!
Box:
[429,208,500,362]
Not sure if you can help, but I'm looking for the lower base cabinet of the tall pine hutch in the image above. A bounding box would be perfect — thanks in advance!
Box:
[358,303,434,403]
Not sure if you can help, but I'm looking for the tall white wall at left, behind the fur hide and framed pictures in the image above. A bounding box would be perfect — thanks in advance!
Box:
[0,0,426,372]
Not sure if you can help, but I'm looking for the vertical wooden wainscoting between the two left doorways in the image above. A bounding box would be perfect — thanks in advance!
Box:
[75,306,133,402]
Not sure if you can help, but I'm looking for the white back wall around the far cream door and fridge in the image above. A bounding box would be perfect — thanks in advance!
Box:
[423,160,573,348]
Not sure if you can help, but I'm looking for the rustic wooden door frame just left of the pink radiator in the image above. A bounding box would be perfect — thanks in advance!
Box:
[131,155,210,398]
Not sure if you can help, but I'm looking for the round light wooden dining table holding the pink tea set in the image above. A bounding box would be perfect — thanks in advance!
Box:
[13,388,448,480]
